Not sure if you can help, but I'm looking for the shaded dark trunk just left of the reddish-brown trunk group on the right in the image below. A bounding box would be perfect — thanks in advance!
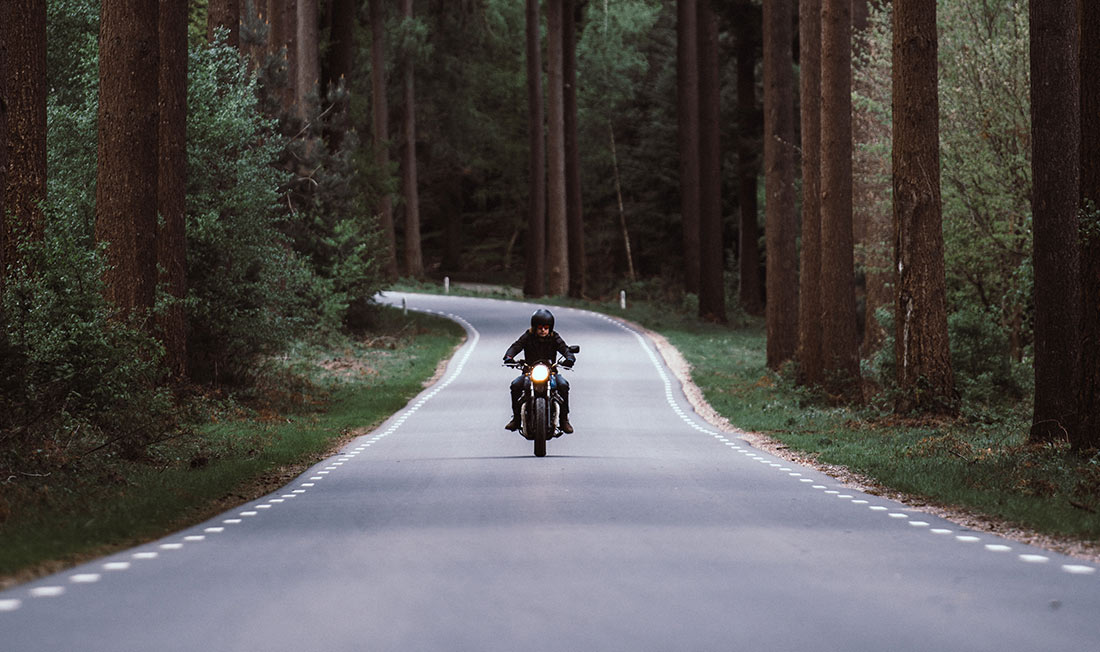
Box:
[737,24,765,316]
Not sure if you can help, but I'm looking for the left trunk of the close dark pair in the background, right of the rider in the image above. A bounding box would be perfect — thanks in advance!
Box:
[677,0,699,294]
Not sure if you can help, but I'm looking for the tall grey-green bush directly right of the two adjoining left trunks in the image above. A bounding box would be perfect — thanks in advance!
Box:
[187,35,321,380]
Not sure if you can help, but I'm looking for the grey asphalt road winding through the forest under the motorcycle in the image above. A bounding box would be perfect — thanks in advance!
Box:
[0,295,1100,652]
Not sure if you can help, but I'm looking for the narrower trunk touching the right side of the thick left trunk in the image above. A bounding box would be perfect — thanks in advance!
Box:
[156,0,187,378]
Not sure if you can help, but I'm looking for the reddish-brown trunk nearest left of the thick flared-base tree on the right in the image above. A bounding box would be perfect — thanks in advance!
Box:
[821,0,862,401]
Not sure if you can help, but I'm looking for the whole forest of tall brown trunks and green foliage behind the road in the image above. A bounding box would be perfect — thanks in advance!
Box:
[0,0,1100,469]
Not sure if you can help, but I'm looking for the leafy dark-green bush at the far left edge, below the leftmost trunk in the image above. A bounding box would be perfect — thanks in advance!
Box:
[0,218,175,473]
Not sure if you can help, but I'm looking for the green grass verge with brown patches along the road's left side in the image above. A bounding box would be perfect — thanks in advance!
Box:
[0,309,464,579]
